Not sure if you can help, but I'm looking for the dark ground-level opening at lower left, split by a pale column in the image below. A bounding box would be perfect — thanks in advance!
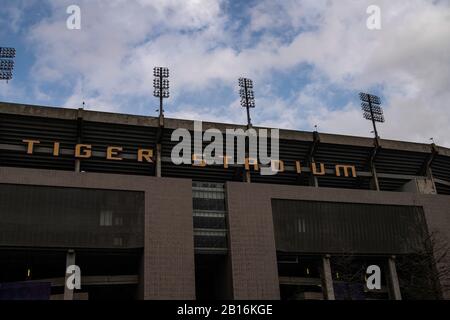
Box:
[0,248,142,300]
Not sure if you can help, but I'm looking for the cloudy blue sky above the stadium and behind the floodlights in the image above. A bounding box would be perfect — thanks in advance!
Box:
[0,0,450,147]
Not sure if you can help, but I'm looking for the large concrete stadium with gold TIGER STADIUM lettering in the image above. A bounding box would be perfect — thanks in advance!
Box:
[0,102,450,300]
